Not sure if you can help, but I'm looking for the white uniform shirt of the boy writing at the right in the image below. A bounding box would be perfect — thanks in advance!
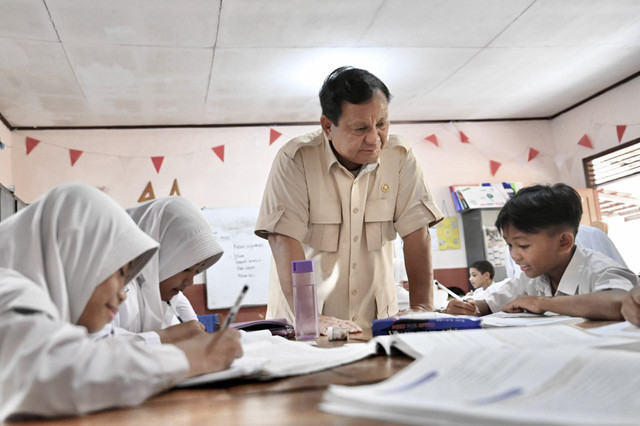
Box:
[485,247,638,312]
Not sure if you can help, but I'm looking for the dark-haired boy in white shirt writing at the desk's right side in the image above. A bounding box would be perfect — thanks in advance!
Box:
[446,184,638,320]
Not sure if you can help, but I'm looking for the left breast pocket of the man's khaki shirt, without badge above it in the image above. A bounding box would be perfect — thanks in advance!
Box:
[307,201,342,252]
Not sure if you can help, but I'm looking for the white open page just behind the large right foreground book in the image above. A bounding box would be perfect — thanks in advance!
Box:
[369,324,627,358]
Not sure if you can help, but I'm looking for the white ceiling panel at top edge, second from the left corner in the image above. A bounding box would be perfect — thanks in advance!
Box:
[47,0,220,47]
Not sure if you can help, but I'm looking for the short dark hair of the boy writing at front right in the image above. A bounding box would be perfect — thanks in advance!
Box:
[496,183,582,236]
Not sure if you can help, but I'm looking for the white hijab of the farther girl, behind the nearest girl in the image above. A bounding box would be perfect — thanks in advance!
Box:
[127,196,223,332]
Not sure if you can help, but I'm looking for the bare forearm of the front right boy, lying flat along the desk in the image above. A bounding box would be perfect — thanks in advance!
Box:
[501,289,627,321]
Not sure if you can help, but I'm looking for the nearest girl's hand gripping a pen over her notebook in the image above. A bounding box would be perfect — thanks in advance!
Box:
[175,323,242,377]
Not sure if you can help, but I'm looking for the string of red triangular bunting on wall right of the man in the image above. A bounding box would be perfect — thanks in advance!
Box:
[424,121,640,176]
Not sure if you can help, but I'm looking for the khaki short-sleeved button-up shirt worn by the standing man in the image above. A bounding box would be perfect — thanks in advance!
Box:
[255,129,442,327]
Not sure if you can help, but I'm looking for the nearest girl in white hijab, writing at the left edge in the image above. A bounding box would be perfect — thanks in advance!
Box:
[0,184,241,422]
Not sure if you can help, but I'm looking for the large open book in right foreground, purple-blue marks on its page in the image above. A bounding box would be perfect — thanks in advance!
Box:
[320,346,640,425]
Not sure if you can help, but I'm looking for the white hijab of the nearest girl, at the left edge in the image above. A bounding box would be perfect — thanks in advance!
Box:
[0,184,157,324]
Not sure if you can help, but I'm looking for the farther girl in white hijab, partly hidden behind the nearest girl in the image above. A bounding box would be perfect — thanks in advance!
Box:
[112,197,223,343]
